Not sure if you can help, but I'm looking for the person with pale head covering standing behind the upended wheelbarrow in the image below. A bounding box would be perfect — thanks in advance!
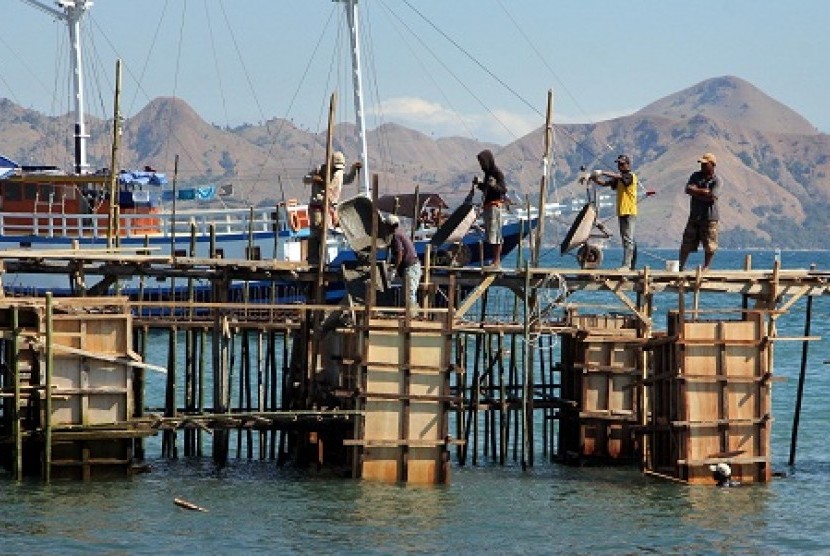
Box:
[303,151,362,265]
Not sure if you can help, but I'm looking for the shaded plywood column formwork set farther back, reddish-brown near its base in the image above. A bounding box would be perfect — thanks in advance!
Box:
[559,315,642,461]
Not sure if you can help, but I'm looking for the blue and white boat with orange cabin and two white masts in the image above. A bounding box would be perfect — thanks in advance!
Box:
[0,0,536,301]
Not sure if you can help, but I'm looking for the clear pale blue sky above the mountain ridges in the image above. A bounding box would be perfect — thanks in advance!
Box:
[0,0,830,145]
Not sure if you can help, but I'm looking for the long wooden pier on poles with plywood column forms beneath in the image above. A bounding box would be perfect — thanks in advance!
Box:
[0,249,830,483]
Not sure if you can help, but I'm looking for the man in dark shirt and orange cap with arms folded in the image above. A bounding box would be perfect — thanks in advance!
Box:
[680,153,720,270]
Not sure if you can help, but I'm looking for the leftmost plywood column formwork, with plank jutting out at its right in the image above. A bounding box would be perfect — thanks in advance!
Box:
[0,298,151,480]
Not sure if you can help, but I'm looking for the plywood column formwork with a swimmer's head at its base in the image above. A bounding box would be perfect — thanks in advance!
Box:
[646,311,772,484]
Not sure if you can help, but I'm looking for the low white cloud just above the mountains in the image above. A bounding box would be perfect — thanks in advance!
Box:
[375,97,544,144]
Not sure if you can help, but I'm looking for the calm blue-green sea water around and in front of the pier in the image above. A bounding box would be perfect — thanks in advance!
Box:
[0,250,830,554]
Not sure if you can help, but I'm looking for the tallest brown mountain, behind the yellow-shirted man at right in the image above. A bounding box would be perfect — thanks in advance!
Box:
[499,77,830,248]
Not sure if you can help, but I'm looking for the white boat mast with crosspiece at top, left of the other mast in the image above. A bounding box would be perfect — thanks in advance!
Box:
[23,0,92,174]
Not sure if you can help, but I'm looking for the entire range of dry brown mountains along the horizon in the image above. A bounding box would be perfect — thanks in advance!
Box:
[0,76,830,248]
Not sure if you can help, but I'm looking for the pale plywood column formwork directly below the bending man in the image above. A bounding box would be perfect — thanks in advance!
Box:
[345,318,450,484]
